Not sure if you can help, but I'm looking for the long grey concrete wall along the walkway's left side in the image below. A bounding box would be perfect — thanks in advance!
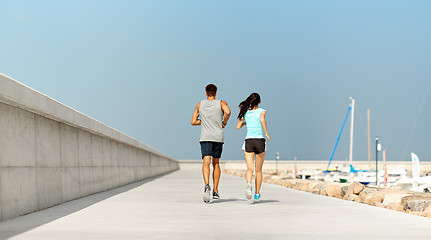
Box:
[0,74,179,221]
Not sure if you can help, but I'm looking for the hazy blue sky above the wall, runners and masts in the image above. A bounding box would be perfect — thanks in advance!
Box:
[0,0,431,160]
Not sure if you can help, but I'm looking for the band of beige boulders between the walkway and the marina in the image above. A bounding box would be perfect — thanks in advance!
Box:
[223,169,431,218]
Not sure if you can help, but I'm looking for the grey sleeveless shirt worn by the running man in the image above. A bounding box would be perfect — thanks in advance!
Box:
[199,100,224,143]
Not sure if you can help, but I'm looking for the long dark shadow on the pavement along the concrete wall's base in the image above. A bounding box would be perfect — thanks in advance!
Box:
[0,172,177,240]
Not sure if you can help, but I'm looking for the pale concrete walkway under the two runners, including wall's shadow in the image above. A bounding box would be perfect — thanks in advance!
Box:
[0,164,431,240]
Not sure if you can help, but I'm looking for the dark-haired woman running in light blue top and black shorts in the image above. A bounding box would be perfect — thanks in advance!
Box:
[236,93,271,201]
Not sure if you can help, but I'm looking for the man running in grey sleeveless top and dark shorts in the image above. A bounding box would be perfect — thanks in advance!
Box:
[191,84,230,203]
